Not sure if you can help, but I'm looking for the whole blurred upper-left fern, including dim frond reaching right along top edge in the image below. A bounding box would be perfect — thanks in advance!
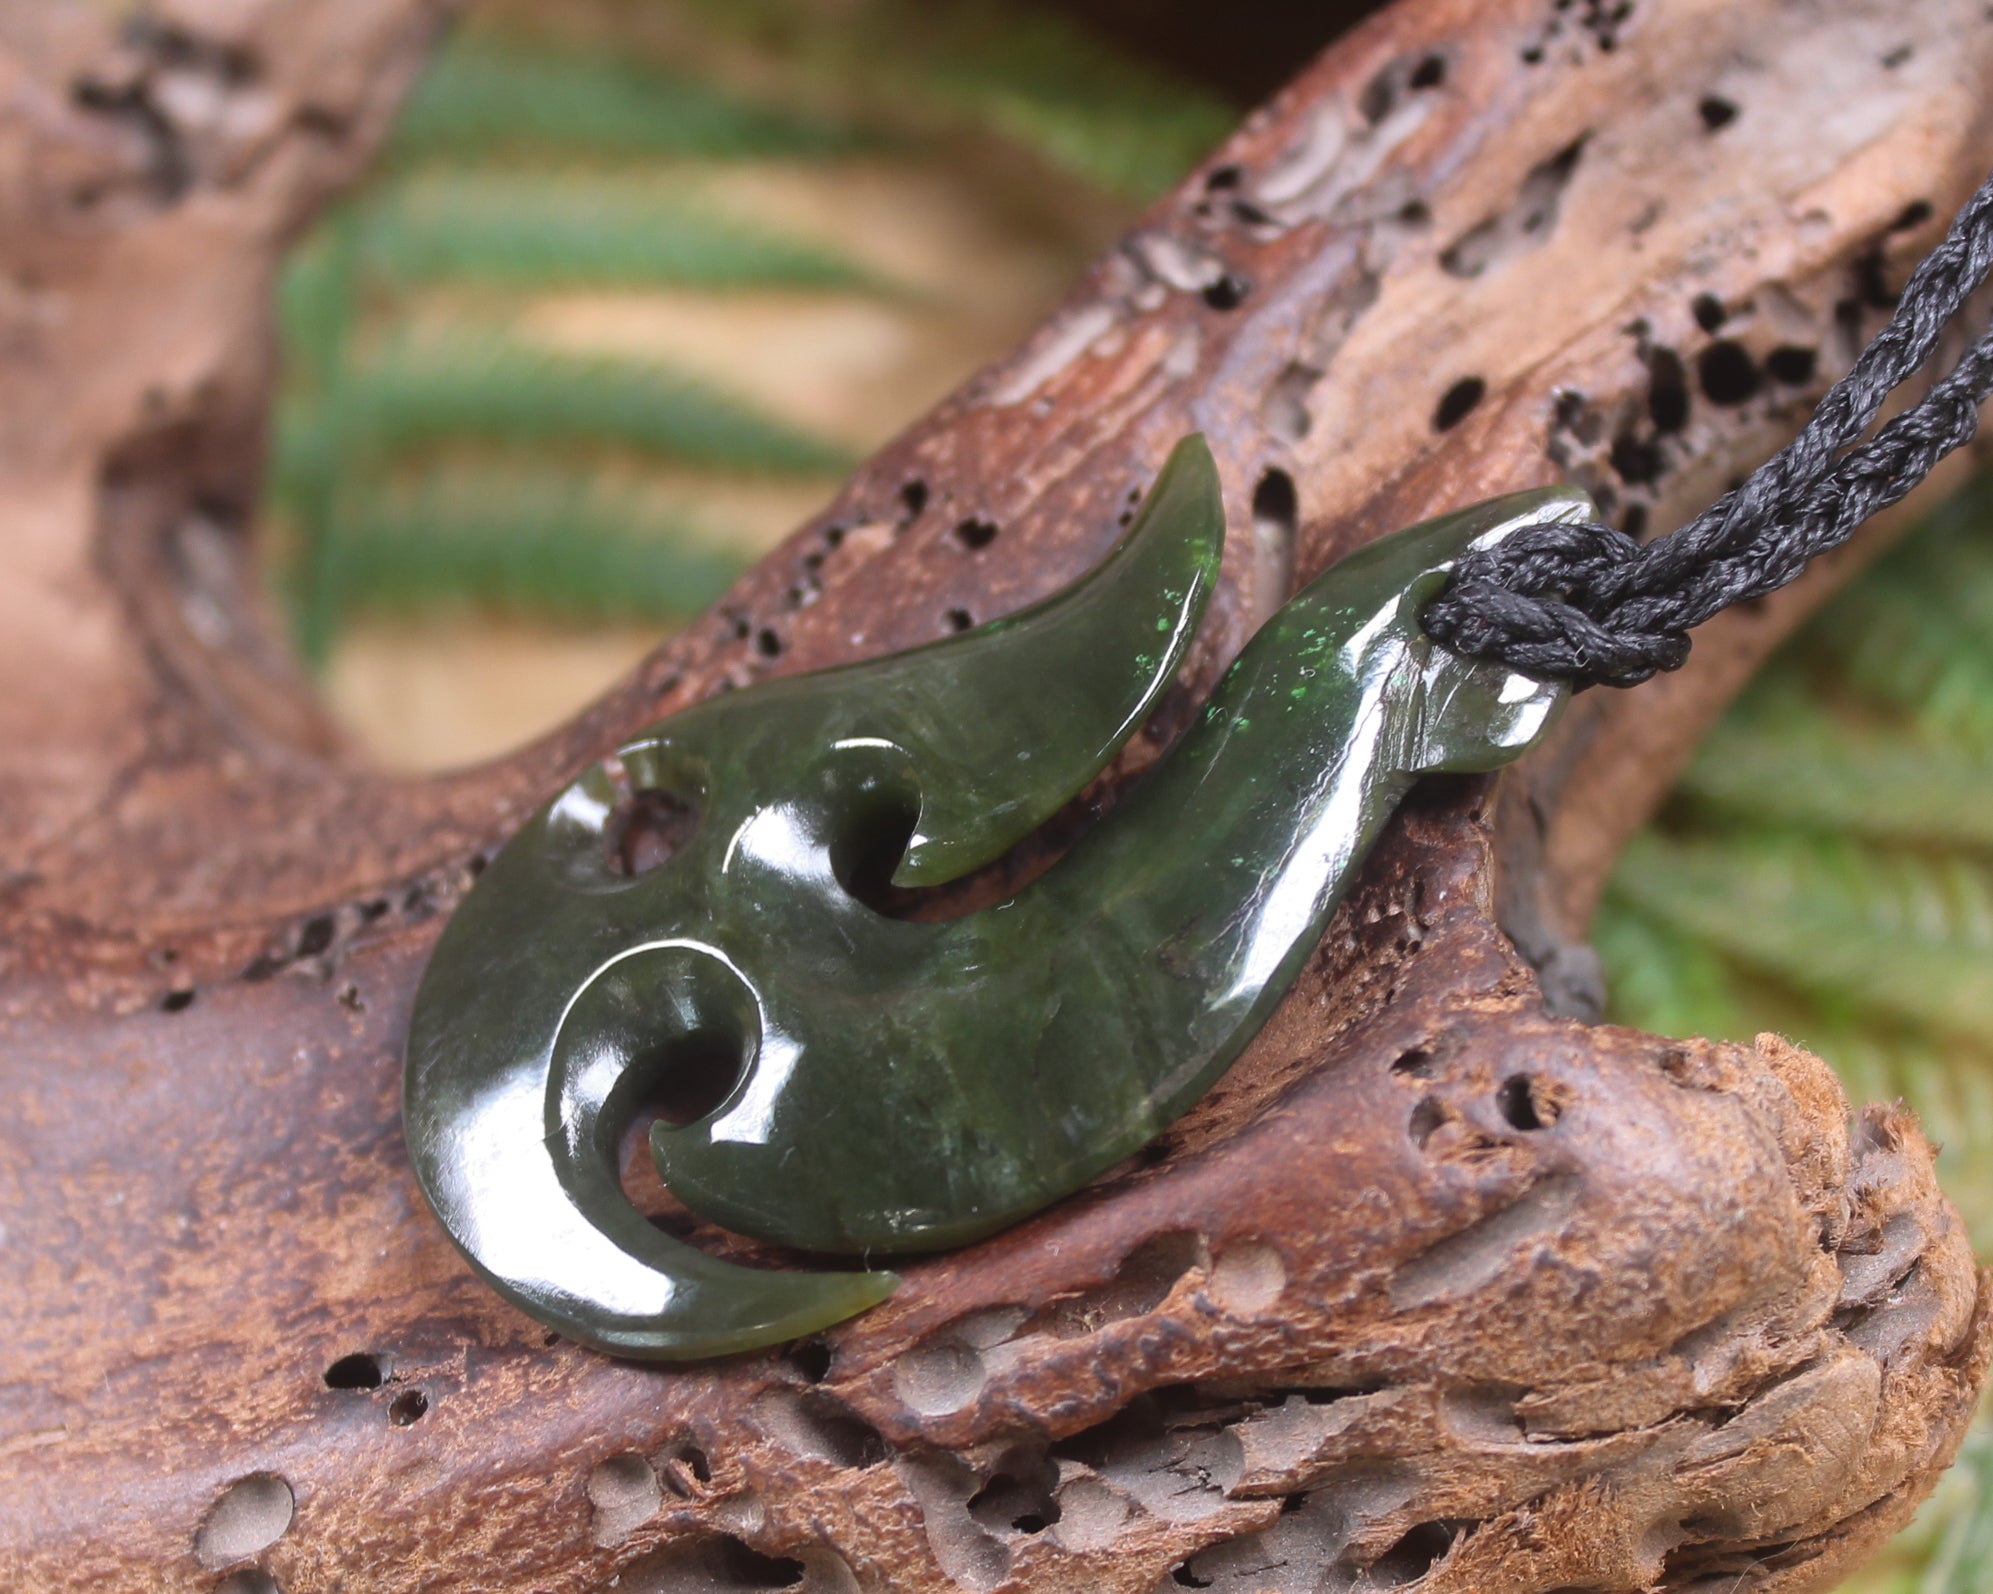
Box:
[271,0,1230,664]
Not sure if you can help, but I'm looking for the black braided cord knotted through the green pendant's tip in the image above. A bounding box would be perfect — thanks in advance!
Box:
[1423,177,1993,687]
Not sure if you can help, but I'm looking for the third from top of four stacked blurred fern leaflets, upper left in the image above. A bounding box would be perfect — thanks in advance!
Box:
[325,331,851,476]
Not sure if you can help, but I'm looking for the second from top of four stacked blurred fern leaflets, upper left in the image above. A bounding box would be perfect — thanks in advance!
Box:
[361,171,881,291]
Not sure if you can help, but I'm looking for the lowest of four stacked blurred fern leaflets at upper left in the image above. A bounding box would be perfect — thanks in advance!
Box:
[327,470,745,622]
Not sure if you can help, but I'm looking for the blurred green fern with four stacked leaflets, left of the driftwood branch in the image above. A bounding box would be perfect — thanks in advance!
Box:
[271,32,868,662]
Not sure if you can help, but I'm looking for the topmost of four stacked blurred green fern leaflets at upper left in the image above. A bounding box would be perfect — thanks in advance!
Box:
[391,32,855,163]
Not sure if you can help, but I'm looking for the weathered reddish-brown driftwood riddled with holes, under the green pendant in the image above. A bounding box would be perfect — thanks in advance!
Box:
[0,0,1993,1594]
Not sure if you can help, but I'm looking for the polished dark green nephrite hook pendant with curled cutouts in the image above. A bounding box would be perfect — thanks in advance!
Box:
[405,438,1592,1359]
